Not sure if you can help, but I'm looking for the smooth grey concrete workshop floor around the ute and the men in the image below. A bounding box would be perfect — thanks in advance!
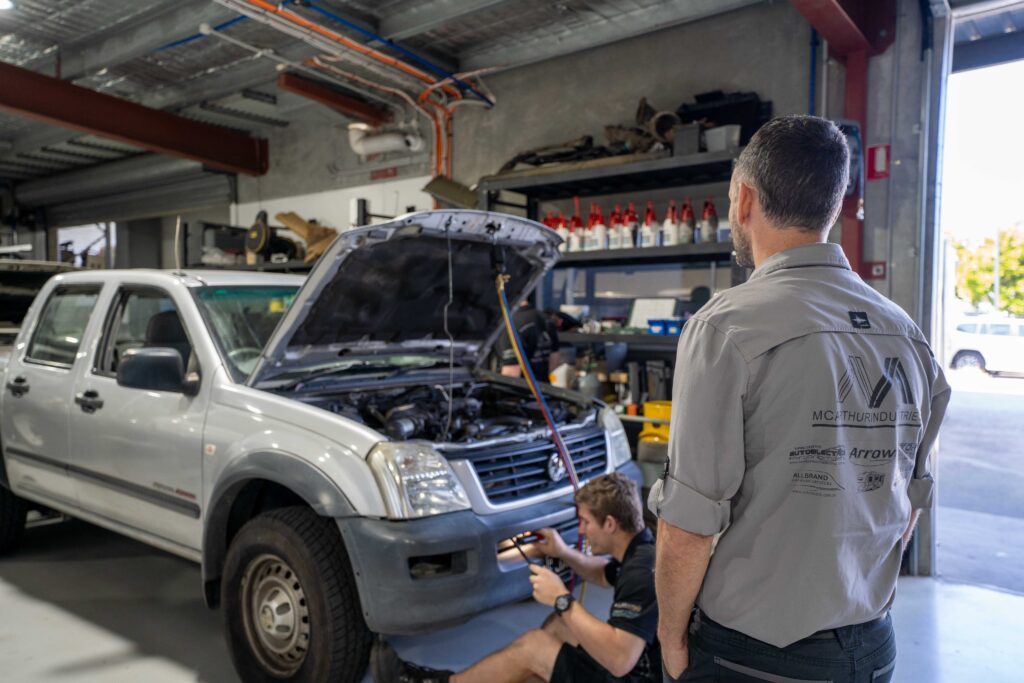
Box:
[0,521,1024,683]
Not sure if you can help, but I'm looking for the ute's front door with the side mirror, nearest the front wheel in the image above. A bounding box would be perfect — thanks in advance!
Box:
[70,286,205,550]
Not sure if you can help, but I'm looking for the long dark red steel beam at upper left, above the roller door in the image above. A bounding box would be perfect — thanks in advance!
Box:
[0,63,268,175]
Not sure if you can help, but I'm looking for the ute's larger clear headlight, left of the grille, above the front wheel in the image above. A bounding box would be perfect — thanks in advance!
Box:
[370,441,470,519]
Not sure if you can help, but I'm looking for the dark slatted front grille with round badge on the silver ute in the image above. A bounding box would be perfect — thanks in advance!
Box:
[458,427,608,503]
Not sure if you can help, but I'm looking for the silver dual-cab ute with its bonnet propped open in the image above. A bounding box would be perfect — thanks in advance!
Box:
[0,211,640,681]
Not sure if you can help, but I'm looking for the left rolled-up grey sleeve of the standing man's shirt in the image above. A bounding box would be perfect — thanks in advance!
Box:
[647,321,749,536]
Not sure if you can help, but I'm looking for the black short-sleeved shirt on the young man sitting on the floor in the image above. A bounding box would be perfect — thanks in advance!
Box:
[604,528,657,648]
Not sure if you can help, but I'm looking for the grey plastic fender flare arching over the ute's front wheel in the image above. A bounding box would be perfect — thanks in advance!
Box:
[203,451,357,607]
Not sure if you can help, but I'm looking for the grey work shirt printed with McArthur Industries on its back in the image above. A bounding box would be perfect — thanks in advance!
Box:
[649,244,949,647]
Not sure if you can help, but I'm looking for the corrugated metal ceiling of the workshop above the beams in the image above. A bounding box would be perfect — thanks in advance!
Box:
[0,0,754,184]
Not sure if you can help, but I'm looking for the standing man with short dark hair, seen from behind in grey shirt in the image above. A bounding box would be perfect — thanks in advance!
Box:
[649,116,949,683]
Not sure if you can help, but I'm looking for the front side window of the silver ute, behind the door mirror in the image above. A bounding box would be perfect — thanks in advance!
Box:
[95,289,193,376]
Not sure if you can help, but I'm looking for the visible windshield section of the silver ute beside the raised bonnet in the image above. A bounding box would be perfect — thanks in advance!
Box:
[195,287,299,382]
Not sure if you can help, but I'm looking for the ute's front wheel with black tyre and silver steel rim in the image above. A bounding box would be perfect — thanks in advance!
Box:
[221,507,372,683]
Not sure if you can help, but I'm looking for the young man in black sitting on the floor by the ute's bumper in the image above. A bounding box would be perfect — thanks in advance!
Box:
[371,474,662,683]
